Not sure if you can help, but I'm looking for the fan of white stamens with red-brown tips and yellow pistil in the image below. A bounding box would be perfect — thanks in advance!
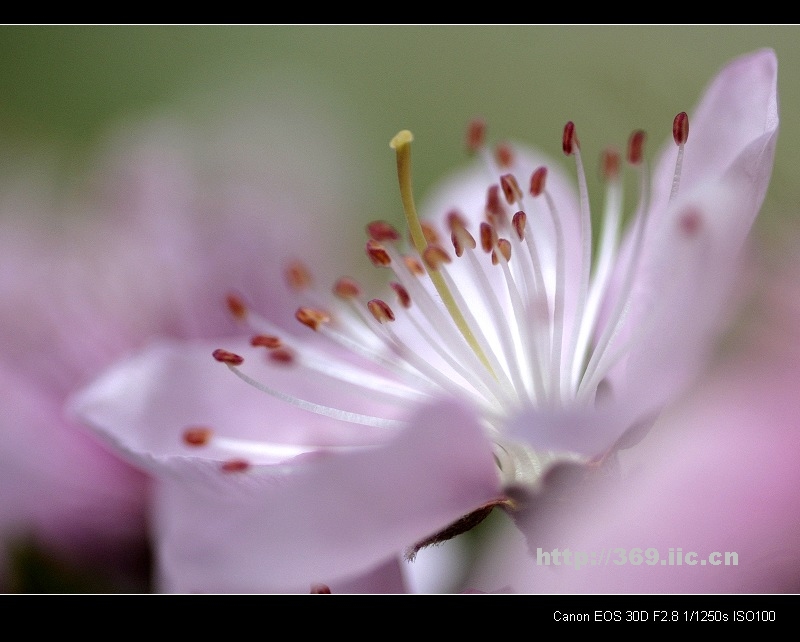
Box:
[198,113,688,481]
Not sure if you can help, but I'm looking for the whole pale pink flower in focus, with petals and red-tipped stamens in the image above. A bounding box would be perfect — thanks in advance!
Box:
[73,50,778,591]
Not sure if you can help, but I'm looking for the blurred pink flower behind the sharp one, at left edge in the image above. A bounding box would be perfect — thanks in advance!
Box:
[0,104,362,590]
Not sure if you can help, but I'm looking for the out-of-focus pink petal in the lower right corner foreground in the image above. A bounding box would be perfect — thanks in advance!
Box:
[518,364,800,593]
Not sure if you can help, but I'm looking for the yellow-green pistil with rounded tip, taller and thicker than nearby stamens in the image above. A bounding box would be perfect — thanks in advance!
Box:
[389,129,494,374]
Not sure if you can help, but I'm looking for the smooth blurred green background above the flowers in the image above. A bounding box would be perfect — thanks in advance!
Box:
[0,25,800,242]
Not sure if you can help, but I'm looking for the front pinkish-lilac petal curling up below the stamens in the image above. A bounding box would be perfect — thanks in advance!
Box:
[151,404,499,591]
